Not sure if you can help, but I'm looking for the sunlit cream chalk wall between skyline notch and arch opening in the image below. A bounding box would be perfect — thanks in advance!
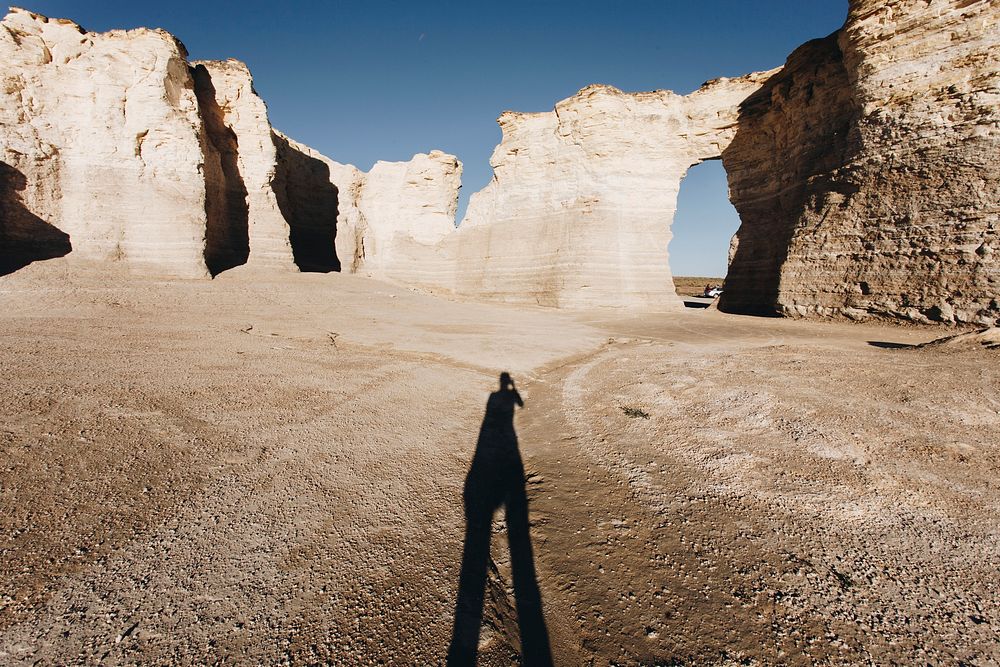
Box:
[454,78,768,309]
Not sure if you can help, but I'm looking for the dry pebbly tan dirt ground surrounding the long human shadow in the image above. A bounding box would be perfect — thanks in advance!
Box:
[0,260,1000,665]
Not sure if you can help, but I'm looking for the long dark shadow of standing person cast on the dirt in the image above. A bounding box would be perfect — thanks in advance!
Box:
[448,373,552,666]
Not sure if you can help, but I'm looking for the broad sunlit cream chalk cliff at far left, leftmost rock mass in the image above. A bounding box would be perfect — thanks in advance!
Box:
[0,9,206,276]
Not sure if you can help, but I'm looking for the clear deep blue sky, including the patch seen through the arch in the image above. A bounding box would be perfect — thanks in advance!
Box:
[21,0,847,276]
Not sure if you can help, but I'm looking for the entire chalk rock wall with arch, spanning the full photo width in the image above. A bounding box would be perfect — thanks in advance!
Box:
[0,0,1000,325]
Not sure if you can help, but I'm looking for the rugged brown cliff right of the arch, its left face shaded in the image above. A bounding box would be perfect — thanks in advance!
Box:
[721,0,1000,324]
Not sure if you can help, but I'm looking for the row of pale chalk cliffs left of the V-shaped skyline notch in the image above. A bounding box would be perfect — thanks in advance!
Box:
[0,9,461,280]
